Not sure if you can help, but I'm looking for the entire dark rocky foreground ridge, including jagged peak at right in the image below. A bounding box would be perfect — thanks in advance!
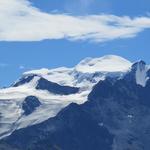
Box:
[0,56,150,150]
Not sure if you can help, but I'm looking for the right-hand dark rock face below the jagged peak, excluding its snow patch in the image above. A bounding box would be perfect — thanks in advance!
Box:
[85,61,150,150]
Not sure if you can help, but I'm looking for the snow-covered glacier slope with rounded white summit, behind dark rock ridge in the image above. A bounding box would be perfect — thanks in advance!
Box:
[0,55,131,139]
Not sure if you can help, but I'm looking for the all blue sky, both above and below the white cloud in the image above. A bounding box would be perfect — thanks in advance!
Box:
[0,0,150,87]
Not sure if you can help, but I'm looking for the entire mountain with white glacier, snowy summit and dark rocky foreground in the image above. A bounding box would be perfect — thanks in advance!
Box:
[0,55,150,150]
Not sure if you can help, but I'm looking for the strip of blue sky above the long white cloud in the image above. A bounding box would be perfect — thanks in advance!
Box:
[30,0,150,16]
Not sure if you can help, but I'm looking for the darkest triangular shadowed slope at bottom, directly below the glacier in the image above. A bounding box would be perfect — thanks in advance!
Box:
[2,104,113,150]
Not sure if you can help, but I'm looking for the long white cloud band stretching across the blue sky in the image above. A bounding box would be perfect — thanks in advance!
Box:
[0,0,150,42]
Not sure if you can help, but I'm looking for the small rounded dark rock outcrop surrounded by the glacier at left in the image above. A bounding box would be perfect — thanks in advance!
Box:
[22,96,41,116]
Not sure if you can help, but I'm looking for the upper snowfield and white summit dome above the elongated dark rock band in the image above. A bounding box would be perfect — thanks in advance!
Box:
[19,55,132,87]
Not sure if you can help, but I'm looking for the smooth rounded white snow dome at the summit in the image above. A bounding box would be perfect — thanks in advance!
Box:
[76,55,132,73]
